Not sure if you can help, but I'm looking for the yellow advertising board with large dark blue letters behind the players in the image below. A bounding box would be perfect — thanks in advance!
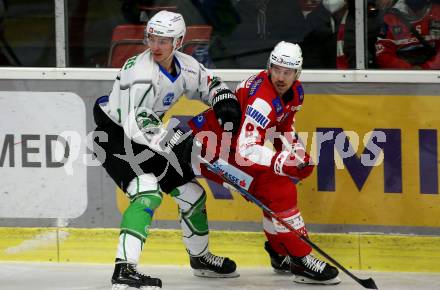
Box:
[115,94,440,228]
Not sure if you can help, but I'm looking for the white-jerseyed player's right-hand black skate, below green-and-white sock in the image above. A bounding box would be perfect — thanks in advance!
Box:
[189,252,240,278]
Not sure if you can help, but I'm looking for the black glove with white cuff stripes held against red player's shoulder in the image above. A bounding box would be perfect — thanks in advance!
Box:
[212,89,241,133]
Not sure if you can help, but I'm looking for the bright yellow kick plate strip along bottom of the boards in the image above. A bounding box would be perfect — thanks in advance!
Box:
[0,228,440,272]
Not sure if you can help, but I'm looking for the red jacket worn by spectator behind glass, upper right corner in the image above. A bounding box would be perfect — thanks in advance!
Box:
[376,2,440,69]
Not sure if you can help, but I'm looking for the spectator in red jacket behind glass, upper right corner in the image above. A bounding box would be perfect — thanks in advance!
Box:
[376,0,440,69]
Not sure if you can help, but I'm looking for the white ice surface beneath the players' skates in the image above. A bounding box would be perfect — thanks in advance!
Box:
[0,262,440,290]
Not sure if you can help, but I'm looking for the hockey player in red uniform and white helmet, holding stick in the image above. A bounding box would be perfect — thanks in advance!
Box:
[189,41,340,284]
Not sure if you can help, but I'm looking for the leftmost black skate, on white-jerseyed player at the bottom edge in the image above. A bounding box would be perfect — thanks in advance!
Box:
[112,259,162,290]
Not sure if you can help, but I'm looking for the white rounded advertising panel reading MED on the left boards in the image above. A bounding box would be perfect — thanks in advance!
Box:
[0,91,90,218]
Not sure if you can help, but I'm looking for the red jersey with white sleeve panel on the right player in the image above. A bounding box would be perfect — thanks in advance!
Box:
[235,71,304,166]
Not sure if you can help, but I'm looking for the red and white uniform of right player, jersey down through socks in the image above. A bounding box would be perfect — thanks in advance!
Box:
[189,71,312,257]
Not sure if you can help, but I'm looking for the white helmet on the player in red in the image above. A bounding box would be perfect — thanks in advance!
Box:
[268,41,303,79]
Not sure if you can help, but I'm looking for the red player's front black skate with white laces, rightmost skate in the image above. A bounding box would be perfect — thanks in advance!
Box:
[290,254,341,285]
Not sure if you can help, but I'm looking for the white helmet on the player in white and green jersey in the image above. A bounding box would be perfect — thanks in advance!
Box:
[145,10,186,49]
